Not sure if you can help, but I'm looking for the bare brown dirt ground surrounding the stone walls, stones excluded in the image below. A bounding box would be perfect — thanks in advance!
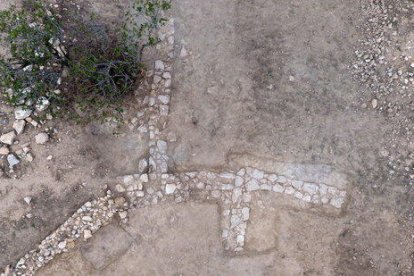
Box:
[0,0,414,275]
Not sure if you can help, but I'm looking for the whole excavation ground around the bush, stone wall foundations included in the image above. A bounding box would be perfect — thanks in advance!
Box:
[0,0,414,275]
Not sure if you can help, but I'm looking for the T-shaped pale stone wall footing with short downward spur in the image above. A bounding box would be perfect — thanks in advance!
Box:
[117,167,346,252]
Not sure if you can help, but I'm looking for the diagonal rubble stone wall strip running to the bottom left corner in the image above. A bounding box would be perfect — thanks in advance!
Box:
[5,190,128,276]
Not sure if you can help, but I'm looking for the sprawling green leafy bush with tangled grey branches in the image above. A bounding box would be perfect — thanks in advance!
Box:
[0,0,171,121]
